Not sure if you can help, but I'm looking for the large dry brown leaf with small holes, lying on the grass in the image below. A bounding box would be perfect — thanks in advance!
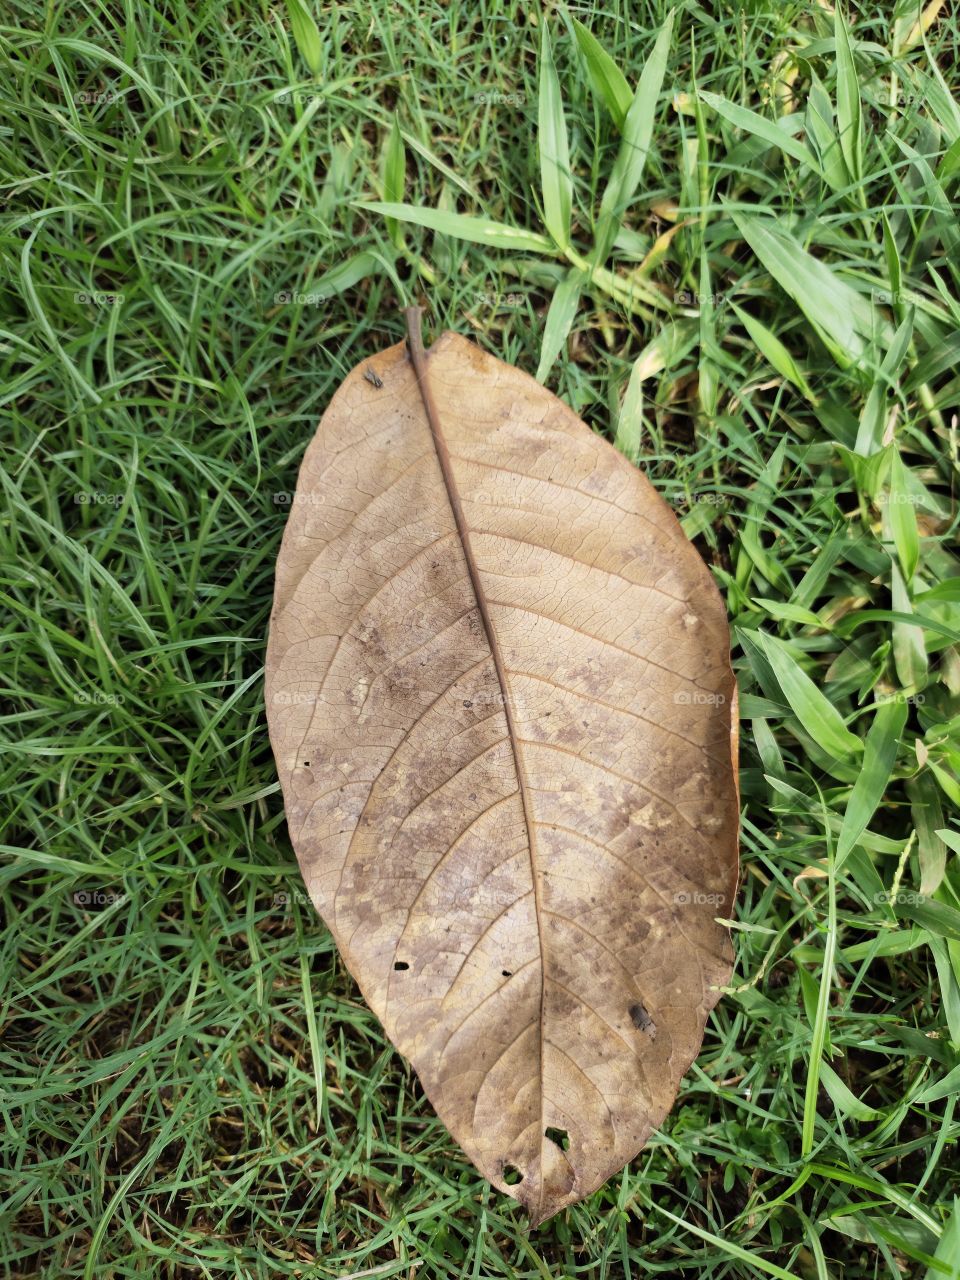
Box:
[266,304,737,1224]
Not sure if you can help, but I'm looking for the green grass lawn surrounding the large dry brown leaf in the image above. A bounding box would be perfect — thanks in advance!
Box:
[0,0,960,1280]
